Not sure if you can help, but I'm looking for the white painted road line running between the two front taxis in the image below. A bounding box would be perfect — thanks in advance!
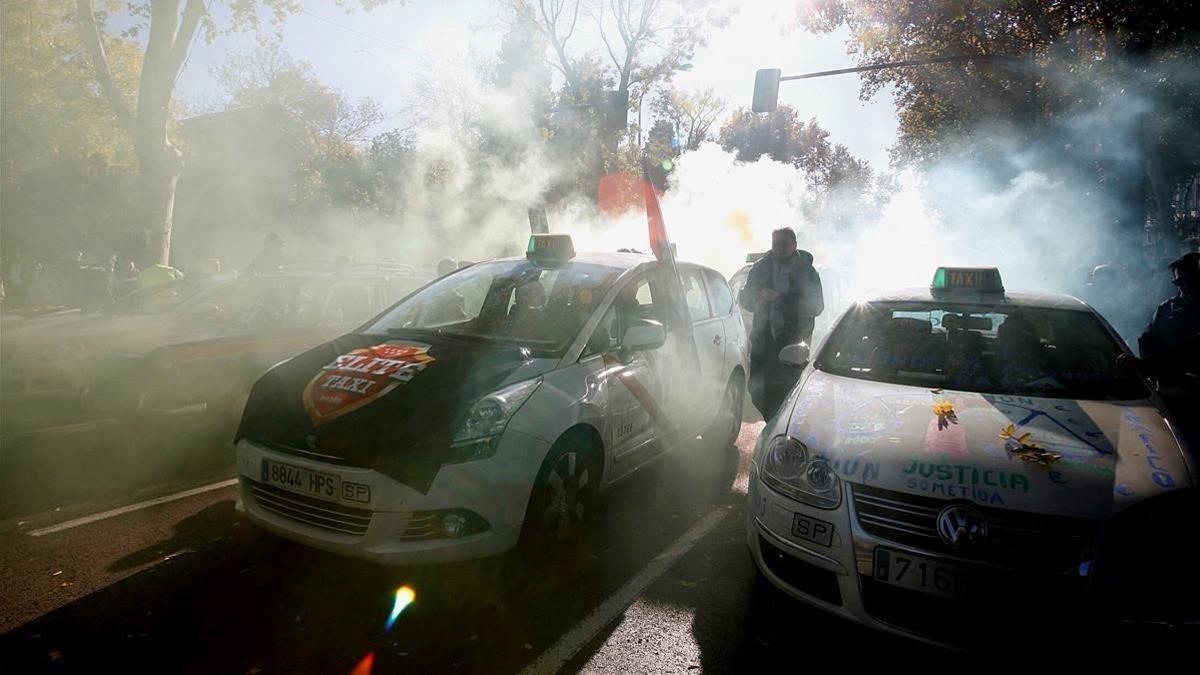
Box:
[521,509,727,675]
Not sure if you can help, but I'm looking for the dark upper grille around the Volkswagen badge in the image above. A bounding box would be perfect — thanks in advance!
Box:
[852,485,1096,573]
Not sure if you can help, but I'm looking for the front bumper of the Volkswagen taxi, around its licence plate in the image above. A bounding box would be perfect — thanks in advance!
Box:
[746,467,1123,651]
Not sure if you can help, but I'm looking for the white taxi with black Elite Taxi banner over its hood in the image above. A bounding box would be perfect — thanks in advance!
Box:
[236,235,746,565]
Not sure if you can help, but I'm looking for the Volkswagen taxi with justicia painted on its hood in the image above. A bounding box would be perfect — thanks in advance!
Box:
[746,268,1200,647]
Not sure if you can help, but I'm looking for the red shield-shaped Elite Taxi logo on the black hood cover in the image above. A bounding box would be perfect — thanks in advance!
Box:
[304,342,434,424]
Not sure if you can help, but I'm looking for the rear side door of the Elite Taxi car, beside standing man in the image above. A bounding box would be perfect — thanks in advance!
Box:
[681,265,725,427]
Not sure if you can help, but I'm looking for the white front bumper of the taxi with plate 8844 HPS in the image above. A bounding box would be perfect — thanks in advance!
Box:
[236,430,550,566]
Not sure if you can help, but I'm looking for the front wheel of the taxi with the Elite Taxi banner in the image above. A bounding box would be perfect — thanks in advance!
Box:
[521,436,600,554]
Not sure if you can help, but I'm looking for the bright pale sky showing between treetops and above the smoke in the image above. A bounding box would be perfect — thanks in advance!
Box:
[171,0,896,168]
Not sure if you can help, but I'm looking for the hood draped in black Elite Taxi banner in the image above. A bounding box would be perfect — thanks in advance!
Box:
[236,331,558,492]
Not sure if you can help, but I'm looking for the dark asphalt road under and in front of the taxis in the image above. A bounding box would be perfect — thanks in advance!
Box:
[0,424,943,674]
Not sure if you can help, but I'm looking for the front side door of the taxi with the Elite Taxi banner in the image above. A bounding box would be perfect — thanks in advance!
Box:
[580,267,678,480]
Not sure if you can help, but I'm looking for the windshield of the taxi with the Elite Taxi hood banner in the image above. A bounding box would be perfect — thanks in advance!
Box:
[364,261,620,351]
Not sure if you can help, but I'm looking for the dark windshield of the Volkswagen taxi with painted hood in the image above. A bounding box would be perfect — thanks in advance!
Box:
[816,303,1147,400]
